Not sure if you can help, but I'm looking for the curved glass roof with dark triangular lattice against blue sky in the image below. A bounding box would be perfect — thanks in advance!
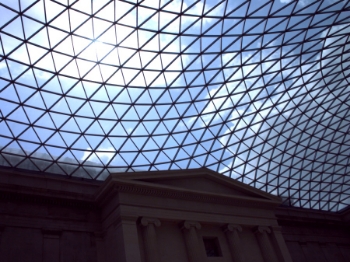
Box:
[0,0,350,211]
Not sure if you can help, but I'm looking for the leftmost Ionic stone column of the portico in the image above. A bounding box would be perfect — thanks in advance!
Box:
[140,217,160,262]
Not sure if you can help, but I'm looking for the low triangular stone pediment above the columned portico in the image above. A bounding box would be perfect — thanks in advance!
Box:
[108,168,279,201]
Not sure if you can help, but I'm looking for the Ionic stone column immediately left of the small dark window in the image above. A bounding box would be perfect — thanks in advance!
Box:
[181,221,204,262]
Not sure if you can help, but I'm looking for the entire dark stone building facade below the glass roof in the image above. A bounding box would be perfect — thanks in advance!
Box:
[0,169,350,262]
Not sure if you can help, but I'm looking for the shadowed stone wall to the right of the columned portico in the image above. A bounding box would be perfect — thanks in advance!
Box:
[276,208,350,262]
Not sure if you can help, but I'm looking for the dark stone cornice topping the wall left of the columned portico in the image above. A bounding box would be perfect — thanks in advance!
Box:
[0,168,102,208]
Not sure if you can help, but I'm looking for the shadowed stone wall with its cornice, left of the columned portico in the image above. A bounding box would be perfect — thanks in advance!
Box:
[0,170,100,262]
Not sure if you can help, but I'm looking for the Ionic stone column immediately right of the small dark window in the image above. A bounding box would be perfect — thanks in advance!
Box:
[223,224,244,262]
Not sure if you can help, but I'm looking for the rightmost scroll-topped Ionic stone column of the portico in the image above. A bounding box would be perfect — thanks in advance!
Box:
[254,226,278,262]
